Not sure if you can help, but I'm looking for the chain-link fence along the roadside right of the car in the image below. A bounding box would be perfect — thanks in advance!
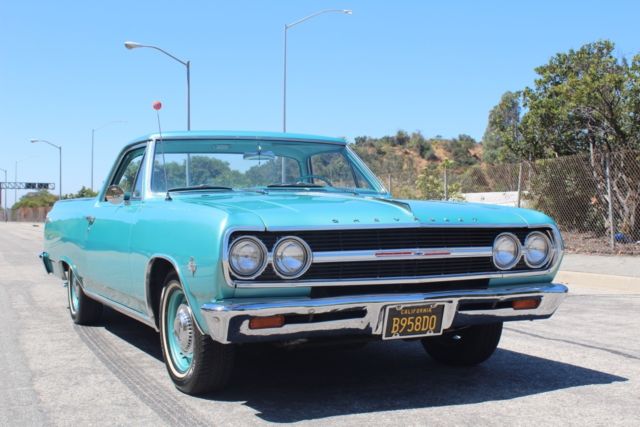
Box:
[442,151,640,255]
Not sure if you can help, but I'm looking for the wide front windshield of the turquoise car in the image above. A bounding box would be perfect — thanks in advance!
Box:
[151,140,384,193]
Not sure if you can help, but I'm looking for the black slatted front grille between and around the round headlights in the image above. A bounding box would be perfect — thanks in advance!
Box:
[230,227,549,282]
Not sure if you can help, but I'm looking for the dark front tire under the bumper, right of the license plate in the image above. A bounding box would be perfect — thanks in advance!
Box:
[421,322,502,366]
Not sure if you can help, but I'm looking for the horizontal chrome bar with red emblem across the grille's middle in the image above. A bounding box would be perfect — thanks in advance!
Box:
[313,246,492,263]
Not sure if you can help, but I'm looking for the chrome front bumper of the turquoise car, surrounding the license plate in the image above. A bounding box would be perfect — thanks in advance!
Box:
[201,283,568,344]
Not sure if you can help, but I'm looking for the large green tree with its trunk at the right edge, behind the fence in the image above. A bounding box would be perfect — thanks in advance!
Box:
[512,40,640,236]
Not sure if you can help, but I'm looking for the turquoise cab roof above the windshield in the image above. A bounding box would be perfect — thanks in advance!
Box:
[129,130,347,145]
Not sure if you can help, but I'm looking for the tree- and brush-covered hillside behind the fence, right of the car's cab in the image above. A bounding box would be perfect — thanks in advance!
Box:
[354,40,640,252]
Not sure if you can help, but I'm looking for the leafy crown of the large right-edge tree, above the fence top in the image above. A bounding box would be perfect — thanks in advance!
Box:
[523,40,640,157]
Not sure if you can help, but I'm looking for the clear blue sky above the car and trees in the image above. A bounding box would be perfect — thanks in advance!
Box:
[0,0,640,204]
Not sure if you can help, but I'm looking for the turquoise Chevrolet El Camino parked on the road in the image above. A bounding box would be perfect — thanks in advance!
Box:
[41,131,567,394]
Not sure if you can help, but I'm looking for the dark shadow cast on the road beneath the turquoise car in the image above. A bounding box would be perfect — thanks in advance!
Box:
[99,313,627,423]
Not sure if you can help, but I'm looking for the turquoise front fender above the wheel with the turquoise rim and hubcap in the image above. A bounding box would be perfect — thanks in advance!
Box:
[130,200,264,333]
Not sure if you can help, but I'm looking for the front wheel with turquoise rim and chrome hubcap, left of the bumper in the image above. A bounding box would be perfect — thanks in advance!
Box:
[160,273,234,395]
